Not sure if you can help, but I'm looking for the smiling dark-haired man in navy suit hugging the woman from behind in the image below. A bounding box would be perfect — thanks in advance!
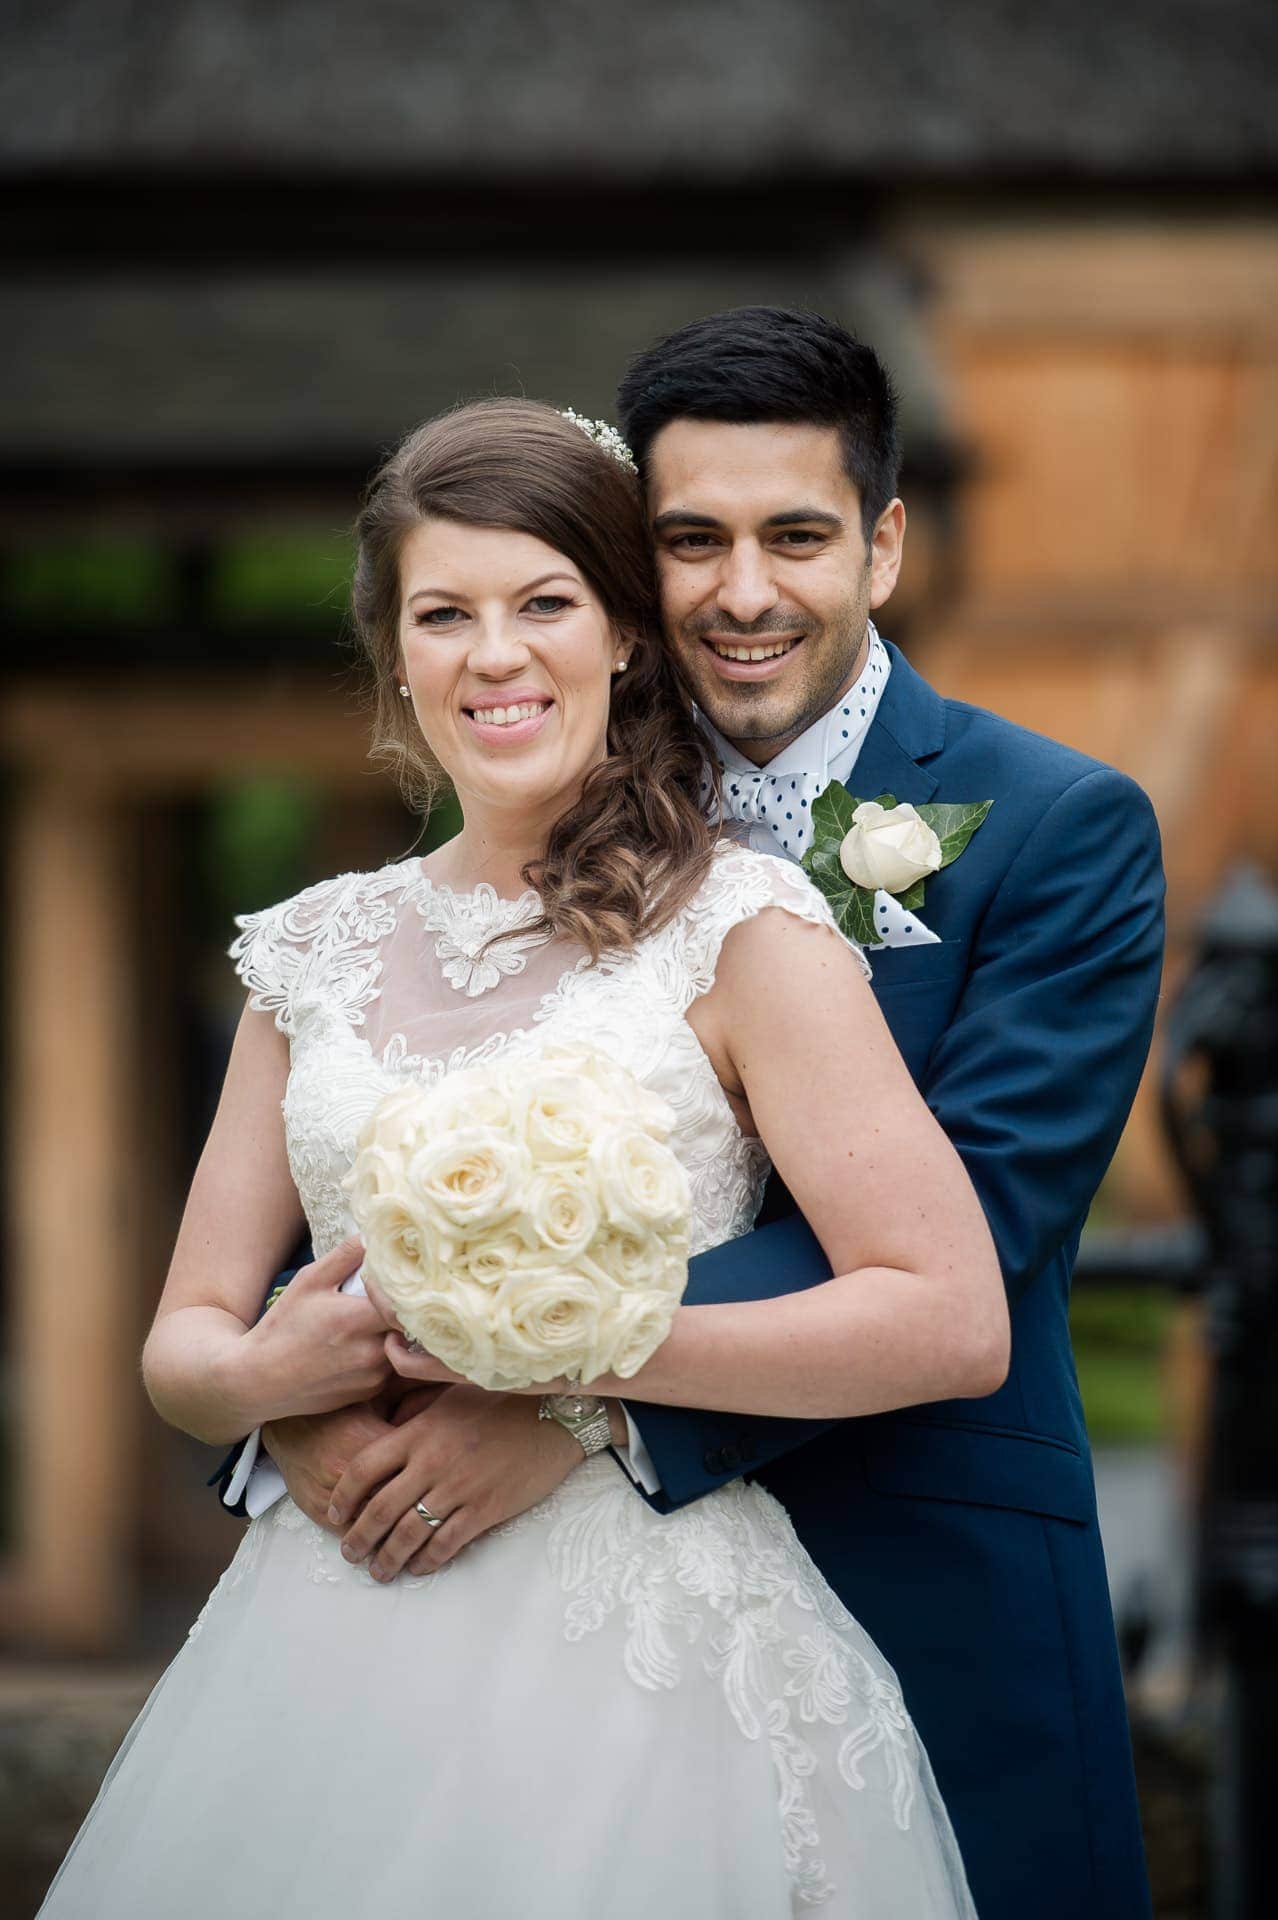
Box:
[216,309,1163,1920]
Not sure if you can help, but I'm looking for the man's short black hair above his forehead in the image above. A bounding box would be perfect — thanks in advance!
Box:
[616,307,900,540]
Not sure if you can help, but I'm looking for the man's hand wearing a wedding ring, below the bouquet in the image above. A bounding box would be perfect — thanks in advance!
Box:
[326,1384,585,1580]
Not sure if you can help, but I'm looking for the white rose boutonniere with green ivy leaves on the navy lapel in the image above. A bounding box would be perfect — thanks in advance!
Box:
[802,781,994,947]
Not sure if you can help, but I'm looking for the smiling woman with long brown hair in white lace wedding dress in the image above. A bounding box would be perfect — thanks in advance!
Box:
[42,401,1007,1920]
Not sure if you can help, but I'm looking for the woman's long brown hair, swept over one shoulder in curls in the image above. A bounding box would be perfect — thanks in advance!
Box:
[351,399,716,958]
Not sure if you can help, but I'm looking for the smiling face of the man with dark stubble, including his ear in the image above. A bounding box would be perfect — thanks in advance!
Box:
[647,419,904,766]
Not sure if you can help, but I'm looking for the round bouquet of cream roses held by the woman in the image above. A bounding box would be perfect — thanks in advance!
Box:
[345,1046,689,1390]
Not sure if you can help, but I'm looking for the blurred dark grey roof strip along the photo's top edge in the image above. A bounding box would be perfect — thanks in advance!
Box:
[0,0,1278,180]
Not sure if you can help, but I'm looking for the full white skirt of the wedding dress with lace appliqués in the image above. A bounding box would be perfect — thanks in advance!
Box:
[40,1453,975,1920]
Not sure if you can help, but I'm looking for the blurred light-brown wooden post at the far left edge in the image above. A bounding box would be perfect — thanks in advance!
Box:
[6,779,138,1651]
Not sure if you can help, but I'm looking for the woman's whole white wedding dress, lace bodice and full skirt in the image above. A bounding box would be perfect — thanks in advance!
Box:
[40,847,975,1920]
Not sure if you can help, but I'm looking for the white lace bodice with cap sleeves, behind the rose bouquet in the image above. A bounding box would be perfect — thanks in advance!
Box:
[230,845,864,1254]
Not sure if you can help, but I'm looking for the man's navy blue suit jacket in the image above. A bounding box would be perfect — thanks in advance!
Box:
[213,647,1163,1920]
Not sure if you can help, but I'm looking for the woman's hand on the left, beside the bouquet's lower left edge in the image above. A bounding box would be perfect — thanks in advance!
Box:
[240,1240,390,1419]
